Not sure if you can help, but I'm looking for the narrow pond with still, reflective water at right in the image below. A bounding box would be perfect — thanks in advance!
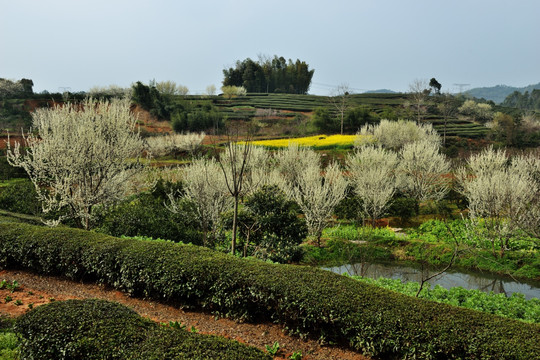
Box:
[325,263,540,299]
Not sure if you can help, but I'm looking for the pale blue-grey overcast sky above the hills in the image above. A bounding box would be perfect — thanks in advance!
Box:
[0,0,540,95]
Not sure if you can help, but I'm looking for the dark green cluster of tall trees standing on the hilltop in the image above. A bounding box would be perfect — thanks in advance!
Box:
[223,55,315,94]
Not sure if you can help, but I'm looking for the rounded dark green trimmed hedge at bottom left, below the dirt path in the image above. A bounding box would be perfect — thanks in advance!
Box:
[14,299,272,360]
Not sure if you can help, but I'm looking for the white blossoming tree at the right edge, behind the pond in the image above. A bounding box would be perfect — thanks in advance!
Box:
[458,148,540,258]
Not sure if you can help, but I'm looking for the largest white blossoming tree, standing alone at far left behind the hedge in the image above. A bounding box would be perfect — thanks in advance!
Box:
[7,98,144,229]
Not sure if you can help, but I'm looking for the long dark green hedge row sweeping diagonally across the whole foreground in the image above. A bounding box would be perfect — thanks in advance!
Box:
[0,224,540,359]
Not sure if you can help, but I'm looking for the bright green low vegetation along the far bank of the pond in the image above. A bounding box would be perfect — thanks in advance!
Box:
[303,220,540,280]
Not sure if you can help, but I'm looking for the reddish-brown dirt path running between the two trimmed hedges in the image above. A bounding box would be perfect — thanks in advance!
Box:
[0,270,369,360]
